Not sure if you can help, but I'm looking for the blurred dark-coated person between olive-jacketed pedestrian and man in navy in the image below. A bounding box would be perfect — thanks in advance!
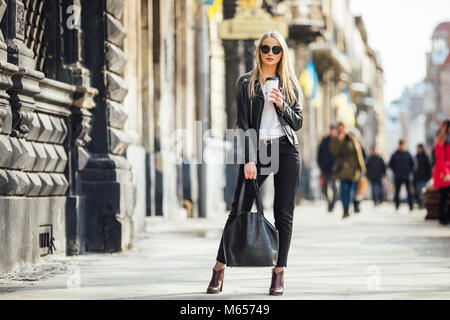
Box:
[366,146,386,206]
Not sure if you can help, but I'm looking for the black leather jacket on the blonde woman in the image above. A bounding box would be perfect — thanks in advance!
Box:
[236,72,304,163]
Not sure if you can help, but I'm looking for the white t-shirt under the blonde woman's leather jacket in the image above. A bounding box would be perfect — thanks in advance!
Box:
[259,84,286,139]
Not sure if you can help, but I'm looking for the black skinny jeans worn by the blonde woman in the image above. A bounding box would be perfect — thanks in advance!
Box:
[216,137,301,267]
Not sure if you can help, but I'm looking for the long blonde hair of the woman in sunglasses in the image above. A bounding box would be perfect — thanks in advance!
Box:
[248,30,303,105]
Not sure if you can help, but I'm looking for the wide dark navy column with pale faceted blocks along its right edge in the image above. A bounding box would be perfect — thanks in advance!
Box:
[79,0,136,252]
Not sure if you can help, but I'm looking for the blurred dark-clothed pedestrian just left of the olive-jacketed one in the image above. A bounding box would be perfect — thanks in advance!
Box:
[317,125,338,212]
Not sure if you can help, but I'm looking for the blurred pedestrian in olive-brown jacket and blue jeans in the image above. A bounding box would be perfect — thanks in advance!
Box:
[330,122,366,218]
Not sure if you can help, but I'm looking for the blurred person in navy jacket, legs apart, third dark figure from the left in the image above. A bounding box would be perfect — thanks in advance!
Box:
[389,139,414,211]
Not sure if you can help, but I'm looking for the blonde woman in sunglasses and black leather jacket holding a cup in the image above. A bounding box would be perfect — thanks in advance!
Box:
[207,31,304,295]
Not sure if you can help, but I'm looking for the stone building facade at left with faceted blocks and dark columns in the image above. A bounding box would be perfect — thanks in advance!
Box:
[0,0,136,272]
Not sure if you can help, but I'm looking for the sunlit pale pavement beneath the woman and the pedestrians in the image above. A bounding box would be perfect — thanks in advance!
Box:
[0,202,450,300]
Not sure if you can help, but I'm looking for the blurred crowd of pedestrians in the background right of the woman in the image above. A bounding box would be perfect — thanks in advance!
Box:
[317,119,450,225]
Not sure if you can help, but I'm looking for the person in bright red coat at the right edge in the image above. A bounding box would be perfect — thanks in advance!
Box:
[433,119,450,225]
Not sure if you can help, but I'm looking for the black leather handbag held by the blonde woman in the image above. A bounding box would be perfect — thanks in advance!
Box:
[223,178,278,267]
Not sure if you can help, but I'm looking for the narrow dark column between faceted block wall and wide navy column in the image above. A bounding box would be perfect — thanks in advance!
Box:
[55,0,98,255]
